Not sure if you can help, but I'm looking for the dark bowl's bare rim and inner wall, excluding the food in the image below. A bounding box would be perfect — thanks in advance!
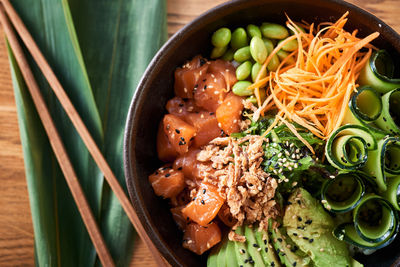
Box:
[124,0,400,267]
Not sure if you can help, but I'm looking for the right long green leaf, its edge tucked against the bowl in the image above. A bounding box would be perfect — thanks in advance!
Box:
[69,0,167,266]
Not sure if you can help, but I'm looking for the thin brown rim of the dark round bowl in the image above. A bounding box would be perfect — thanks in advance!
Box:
[123,0,400,266]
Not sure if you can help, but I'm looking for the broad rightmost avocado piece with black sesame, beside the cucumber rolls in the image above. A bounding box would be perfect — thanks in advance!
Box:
[283,188,352,266]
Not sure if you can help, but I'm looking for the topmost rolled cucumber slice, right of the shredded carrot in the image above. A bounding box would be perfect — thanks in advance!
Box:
[358,50,400,93]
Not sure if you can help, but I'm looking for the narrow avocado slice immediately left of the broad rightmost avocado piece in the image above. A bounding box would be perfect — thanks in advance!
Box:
[270,227,310,266]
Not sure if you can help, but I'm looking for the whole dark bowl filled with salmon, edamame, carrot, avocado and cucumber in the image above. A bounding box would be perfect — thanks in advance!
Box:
[124,0,400,266]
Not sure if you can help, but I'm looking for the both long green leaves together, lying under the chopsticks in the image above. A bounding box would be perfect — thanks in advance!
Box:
[9,0,166,266]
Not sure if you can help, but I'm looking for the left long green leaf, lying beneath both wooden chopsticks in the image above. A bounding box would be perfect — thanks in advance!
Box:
[8,0,103,266]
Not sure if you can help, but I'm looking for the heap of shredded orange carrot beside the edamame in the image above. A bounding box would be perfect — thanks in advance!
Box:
[249,12,379,151]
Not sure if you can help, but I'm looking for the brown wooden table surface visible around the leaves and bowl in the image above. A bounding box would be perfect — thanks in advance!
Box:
[0,0,400,267]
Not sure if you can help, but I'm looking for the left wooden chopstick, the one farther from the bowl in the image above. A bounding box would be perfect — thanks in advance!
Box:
[0,5,115,266]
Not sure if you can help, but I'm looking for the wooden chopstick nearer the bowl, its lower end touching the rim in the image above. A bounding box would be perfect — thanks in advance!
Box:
[1,0,166,266]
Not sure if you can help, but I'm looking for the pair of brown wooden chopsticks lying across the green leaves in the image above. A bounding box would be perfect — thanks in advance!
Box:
[0,0,166,266]
